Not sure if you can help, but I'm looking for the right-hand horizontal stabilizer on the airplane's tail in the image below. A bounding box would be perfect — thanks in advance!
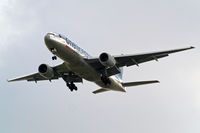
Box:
[122,80,159,87]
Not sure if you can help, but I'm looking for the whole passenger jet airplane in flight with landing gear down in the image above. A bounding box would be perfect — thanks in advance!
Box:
[8,32,194,94]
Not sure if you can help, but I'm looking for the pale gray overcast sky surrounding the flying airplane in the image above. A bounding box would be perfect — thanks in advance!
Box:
[0,0,200,133]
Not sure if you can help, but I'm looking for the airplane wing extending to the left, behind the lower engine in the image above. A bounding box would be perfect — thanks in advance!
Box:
[8,63,82,82]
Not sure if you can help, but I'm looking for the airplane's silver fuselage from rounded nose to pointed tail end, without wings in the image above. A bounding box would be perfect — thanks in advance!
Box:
[44,33,125,92]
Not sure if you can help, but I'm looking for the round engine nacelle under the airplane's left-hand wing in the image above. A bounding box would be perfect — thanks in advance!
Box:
[38,64,54,79]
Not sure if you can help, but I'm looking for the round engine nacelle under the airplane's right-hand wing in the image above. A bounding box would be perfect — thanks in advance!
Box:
[99,53,116,67]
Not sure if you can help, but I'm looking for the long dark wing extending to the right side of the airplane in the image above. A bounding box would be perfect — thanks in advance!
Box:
[86,47,194,75]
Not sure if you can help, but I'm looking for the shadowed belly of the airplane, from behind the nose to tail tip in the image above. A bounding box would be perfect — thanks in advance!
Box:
[53,45,125,92]
